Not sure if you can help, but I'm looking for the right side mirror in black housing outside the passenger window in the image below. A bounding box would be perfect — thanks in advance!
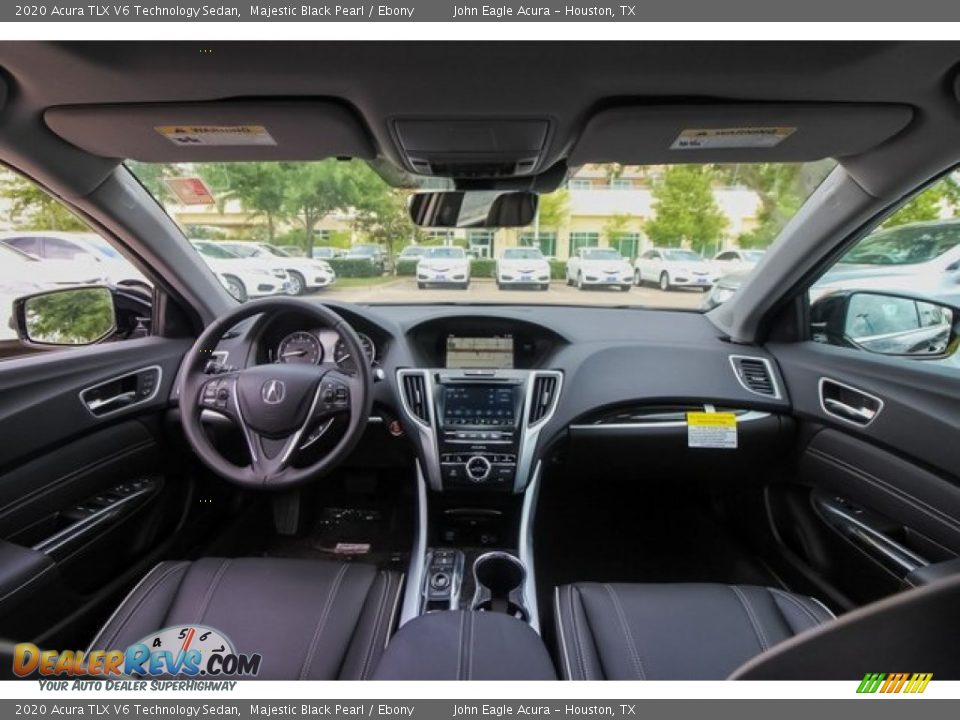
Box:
[810,291,960,359]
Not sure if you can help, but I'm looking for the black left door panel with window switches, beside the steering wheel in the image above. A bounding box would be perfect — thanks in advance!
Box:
[0,338,189,646]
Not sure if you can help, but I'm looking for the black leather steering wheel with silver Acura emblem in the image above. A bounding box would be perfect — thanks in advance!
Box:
[179,297,373,490]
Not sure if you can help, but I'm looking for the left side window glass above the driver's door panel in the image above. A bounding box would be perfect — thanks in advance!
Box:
[0,169,152,361]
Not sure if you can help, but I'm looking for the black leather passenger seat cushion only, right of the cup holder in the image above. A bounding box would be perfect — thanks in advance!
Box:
[554,583,833,680]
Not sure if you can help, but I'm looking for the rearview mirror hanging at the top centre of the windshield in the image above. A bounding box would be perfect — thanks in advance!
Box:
[410,190,539,228]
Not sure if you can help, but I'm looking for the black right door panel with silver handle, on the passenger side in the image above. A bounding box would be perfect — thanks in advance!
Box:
[767,342,960,606]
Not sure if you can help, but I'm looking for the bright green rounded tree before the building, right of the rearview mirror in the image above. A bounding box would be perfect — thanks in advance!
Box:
[644,165,727,252]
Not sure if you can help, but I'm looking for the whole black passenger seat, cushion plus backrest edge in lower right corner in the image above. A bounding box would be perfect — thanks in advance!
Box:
[554,573,960,680]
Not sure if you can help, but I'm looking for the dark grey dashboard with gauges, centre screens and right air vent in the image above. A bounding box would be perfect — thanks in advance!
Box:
[206,301,790,492]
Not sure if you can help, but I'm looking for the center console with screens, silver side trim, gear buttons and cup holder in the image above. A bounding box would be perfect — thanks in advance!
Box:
[397,362,563,629]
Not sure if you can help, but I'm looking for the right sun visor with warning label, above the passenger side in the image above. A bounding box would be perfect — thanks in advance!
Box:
[570,104,913,166]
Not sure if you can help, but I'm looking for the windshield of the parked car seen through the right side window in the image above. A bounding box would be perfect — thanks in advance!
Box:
[840,221,960,265]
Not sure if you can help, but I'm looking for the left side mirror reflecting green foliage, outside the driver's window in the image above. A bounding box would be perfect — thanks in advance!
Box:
[13,286,117,345]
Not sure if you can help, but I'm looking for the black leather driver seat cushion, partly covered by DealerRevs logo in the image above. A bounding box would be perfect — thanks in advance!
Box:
[90,558,402,680]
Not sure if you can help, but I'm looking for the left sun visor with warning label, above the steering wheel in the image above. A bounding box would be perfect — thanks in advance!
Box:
[44,101,375,162]
